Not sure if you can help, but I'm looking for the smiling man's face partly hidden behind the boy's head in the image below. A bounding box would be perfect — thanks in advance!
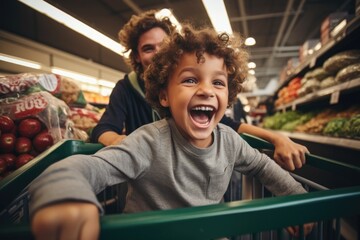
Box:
[136,27,167,70]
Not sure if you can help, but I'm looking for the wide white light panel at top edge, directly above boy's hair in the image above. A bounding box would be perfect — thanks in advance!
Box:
[202,0,233,34]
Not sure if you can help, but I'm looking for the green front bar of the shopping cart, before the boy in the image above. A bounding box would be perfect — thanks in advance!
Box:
[0,186,360,240]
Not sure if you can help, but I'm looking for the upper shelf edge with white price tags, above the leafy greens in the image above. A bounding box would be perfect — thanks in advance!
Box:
[276,78,360,111]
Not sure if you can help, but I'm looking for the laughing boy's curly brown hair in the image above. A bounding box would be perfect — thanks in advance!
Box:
[144,24,248,117]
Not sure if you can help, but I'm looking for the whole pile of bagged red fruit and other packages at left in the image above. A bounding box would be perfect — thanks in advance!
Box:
[0,73,100,179]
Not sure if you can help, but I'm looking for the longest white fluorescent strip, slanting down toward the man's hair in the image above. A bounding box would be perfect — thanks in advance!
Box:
[19,0,125,56]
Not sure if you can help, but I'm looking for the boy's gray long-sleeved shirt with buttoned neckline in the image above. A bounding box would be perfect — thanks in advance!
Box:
[29,119,306,213]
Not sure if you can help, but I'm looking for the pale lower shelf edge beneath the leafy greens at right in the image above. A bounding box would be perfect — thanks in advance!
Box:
[276,131,360,150]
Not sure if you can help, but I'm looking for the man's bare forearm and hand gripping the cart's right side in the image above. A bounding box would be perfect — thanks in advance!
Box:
[238,123,309,171]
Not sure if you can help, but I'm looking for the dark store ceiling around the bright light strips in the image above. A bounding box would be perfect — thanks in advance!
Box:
[0,0,355,89]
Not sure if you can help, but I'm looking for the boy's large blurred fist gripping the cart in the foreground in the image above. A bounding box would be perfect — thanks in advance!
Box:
[31,202,100,240]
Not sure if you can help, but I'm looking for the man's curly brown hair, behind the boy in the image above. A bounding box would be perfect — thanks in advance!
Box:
[118,10,175,74]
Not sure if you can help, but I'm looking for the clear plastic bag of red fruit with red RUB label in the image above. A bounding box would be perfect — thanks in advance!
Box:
[0,91,74,179]
